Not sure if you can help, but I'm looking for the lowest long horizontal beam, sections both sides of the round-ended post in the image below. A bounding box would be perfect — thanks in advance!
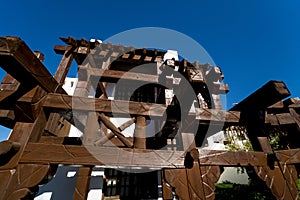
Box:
[20,143,267,168]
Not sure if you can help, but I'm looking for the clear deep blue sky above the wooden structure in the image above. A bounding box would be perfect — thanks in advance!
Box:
[0,0,300,140]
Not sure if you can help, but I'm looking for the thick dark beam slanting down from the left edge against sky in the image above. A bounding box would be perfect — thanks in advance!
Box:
[0,37,66,94]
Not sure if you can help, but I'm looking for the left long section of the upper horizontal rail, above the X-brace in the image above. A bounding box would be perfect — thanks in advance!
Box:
[42,94,166,117]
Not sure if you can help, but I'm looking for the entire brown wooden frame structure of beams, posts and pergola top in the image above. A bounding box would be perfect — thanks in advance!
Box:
[0,37,300,200]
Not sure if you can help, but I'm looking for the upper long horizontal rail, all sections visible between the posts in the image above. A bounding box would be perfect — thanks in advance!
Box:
[38,94,296,125]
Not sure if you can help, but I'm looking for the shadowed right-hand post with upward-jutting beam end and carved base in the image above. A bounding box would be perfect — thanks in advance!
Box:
[232,81,298,200]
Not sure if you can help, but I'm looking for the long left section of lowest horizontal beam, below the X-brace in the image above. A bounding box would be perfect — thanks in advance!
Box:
[20,143,184,168]
